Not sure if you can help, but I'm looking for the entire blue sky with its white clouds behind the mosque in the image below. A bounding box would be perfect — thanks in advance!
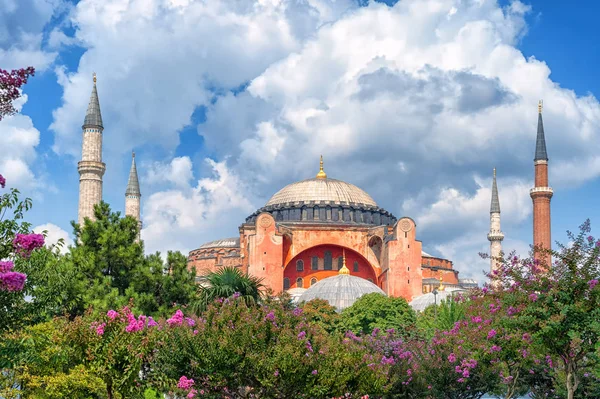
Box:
[0,0,600,286]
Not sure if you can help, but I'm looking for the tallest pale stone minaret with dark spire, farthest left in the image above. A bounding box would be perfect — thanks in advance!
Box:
[77,73,106,225]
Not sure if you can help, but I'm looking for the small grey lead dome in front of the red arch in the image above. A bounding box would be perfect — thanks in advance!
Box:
[298,274,385,312]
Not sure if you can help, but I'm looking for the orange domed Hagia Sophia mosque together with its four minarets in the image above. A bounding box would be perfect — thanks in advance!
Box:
[78,75,553,310]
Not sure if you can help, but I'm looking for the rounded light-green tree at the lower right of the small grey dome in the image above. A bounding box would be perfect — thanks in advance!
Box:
[340,293,417,335]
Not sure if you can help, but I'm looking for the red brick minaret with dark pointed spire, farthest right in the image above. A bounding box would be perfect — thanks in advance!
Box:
[529,100,553,267]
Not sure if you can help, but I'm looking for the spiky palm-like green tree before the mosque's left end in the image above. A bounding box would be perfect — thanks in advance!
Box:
[192,267,264,313]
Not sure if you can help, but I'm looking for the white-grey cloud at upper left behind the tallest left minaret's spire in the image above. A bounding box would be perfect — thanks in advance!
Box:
[51,0,353,156]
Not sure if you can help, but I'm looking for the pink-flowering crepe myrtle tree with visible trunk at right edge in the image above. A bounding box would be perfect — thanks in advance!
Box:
[492,219,600,399]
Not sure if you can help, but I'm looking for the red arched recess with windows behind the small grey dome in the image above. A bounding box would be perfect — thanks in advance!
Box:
[283,244,378,288]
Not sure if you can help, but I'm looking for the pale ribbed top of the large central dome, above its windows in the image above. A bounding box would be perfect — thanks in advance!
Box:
[265,178,377,207]
